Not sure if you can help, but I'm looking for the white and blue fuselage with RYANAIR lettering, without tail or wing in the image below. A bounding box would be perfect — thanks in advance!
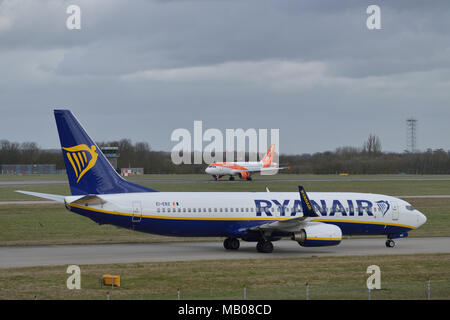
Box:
[66,192,426,240]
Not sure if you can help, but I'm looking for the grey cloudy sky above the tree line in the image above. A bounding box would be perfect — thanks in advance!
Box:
[0,0,450,154]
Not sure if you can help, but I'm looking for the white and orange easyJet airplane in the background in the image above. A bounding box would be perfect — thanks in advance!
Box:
[205,144,285,181]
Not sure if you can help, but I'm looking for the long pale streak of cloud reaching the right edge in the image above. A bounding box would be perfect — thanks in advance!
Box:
[121,60,450,91]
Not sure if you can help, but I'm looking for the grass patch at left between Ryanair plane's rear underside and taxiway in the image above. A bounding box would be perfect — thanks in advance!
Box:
[0,204,211,246]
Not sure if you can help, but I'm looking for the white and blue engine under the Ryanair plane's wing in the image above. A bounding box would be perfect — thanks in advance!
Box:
[292,223,342,247]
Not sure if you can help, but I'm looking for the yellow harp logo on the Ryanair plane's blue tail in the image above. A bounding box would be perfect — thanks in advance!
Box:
[63,144,98,183]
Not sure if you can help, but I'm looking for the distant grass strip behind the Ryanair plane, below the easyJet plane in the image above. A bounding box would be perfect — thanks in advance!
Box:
[0,175,450,201]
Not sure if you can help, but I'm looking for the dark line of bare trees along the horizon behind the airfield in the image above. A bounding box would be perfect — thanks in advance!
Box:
[0,135,450,174]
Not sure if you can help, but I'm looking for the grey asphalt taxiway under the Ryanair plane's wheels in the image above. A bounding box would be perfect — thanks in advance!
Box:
[0,237,450,268]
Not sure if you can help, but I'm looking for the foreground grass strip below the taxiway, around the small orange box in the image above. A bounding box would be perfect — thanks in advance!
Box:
[0,254,450,300]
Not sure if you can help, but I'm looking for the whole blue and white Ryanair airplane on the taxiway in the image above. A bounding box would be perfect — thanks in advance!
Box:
[18,110,427,253]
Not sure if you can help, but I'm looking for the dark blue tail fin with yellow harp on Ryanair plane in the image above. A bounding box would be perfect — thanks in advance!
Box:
[55,110,156,195]
